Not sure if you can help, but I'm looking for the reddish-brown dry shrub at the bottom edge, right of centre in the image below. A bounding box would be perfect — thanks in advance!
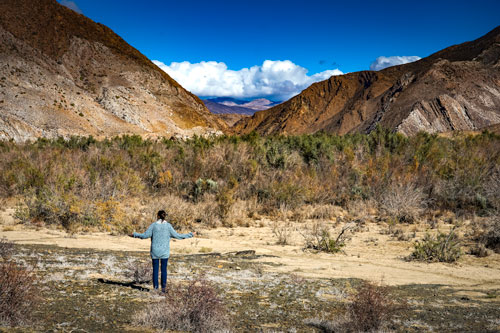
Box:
[348,282,399,332]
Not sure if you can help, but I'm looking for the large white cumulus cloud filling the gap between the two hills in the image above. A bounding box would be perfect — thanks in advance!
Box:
[153,60,343,100]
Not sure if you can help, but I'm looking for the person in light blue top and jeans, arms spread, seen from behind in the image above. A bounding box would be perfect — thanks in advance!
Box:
[129,210,196,293]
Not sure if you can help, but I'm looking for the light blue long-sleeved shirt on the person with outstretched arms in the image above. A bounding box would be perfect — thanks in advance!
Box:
[134,220,193,259]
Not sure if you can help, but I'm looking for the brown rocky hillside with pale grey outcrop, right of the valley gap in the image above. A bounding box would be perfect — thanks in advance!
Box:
[233,27,500,135]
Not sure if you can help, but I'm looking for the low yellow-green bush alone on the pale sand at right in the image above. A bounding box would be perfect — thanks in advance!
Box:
[409,228,462,262]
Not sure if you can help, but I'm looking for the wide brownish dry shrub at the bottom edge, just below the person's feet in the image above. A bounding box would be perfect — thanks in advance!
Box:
[137,279,228,332]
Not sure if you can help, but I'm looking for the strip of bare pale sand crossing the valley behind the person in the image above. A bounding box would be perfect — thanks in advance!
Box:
[0,209,500,290]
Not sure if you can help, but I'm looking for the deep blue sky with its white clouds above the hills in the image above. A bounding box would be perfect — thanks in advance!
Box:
[61,0,500,98]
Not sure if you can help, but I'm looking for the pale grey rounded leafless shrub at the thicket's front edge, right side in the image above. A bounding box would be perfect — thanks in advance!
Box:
[380,184,426,223]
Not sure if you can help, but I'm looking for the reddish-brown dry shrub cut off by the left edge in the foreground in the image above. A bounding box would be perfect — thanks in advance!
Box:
[0,261,39,326]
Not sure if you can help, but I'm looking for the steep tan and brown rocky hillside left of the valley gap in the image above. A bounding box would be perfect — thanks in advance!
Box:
[0,0,226,141]
